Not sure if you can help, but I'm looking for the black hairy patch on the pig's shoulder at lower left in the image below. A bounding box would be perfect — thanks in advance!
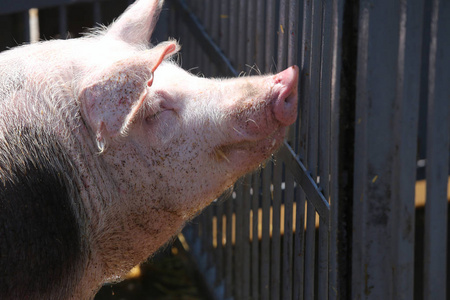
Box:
[0,126,86,299]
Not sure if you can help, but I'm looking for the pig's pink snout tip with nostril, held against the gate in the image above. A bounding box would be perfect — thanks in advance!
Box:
[273,66,298,126]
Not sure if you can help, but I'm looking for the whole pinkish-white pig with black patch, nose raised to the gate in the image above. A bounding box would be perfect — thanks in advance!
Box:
[0,0,298,299]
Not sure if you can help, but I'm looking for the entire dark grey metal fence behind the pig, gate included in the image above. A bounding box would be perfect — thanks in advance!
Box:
[0,0,450,300]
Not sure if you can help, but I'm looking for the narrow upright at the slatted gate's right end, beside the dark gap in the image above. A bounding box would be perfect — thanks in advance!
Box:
[328,0,345,300]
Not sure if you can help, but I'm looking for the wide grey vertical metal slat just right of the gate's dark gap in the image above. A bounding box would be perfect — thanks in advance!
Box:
[352,0,400,299]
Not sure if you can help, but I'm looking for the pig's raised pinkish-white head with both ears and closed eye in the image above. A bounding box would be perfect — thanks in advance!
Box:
[74,0,298,272]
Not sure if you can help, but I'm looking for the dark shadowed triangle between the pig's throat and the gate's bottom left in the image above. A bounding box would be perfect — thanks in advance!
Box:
[94,242,210,300]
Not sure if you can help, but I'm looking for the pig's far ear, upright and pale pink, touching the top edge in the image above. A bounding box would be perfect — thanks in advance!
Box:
[106,0,164,44]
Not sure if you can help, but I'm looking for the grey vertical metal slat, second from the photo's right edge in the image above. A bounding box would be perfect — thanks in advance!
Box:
[391,0,424,300]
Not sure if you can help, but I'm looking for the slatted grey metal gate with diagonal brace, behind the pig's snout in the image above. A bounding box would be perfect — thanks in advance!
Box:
[169,0,350,299]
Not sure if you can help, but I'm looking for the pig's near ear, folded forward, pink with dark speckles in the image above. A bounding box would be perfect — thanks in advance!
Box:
[79,41,179,152]
